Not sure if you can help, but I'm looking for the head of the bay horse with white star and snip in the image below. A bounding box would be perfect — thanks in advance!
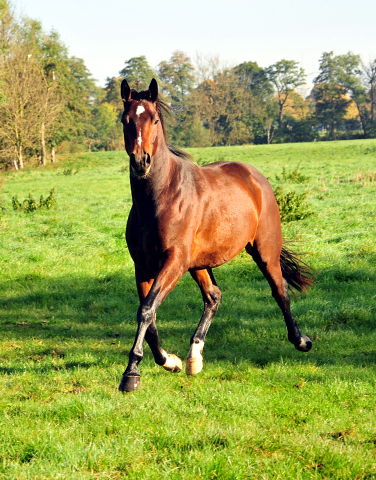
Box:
[121,78,162,178]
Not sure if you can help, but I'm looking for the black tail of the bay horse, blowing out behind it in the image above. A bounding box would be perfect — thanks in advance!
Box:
[280,245,315,294]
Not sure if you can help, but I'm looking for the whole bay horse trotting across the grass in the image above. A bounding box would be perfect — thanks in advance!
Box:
[119,79,312,392]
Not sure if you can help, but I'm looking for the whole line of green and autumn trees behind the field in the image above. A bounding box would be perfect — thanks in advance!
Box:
[0,0,376,169]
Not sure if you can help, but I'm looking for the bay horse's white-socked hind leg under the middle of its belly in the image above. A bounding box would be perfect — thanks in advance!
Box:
[185,268,222,375]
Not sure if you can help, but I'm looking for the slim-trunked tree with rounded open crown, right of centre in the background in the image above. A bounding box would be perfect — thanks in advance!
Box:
[265,60,306,127]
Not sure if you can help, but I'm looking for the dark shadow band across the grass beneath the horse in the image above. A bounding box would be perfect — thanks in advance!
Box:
[0,262,376,374]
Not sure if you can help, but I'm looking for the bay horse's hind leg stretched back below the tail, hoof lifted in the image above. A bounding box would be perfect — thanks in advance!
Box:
[245,241,312,352]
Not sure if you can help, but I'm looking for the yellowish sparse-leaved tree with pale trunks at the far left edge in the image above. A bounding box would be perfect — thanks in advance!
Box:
[0,8,62,168]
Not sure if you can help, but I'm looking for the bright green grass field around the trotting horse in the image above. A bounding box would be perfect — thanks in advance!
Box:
[0,140,376,480]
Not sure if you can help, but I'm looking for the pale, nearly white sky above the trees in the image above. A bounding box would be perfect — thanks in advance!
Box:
[12,0,376,88]
